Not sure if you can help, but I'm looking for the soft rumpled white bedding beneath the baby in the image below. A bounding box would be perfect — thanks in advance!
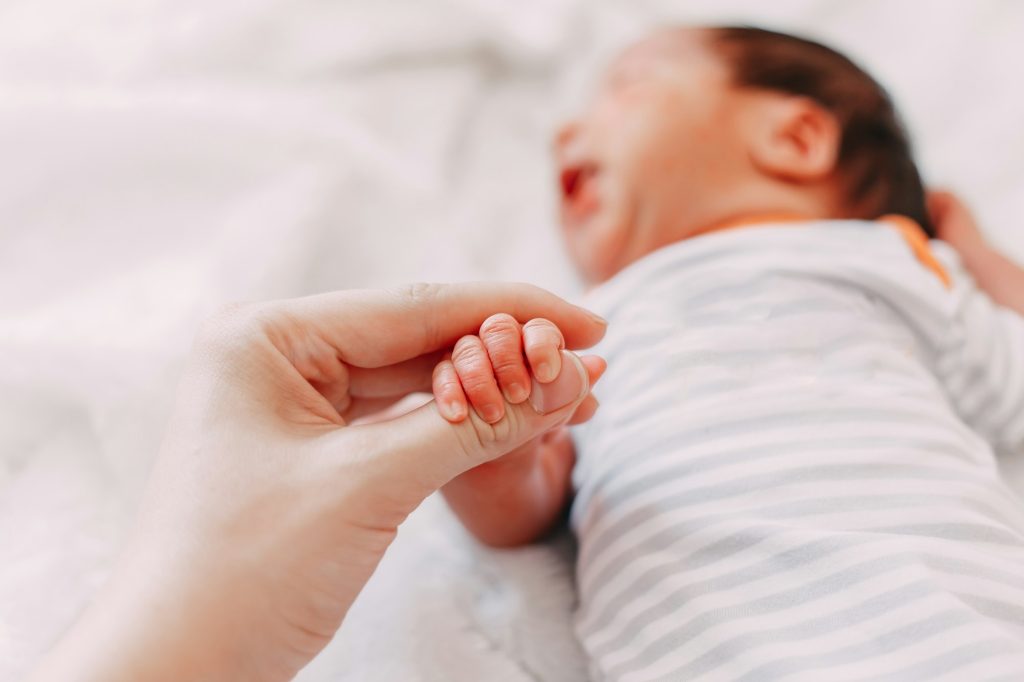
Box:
[0,0,1024,681]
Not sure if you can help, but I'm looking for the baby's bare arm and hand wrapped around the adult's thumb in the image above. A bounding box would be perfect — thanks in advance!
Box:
[433,315,604,547]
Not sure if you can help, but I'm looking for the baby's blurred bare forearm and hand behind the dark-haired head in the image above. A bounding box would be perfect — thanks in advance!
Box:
[928,191,1024,315]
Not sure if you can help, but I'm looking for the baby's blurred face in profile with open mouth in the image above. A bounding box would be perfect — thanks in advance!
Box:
[555,30,742,283]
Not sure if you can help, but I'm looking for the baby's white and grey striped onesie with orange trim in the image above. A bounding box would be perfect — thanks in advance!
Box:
[570,221,1024,682]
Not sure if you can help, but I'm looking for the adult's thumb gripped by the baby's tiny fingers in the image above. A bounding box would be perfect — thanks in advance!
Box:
[339,351,591,504]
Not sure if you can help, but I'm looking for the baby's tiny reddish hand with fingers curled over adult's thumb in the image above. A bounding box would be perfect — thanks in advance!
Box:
[433,313,604,424]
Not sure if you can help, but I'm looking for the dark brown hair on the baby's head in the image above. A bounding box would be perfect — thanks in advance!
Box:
[708,27,935,237]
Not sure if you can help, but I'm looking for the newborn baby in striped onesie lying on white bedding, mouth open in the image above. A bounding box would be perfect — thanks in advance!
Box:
[434,29,1024,682]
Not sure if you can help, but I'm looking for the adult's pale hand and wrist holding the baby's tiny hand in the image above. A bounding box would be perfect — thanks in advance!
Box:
[36,284,604,682]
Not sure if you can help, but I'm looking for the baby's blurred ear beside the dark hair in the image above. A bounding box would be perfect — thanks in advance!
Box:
[744,93,843,183]
